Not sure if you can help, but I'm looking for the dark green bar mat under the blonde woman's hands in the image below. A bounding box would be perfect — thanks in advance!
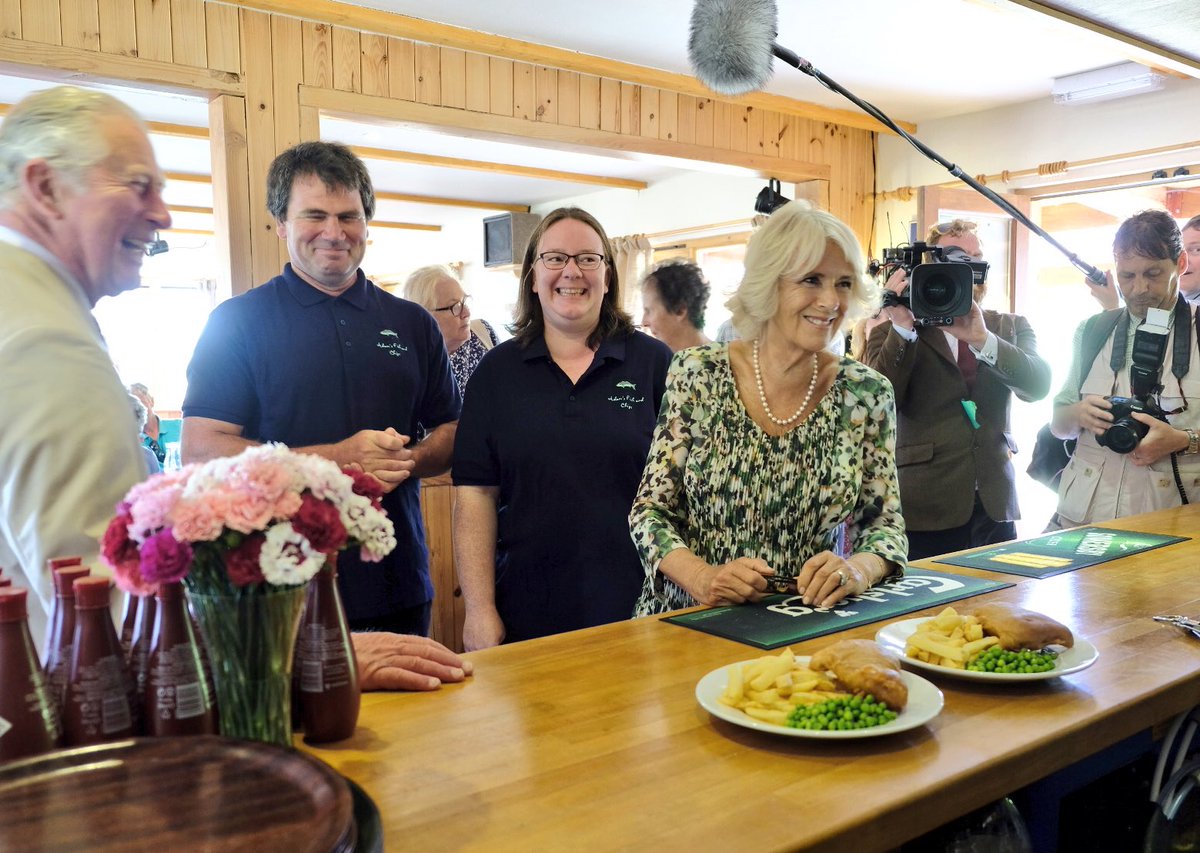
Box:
[664,569,1013,649]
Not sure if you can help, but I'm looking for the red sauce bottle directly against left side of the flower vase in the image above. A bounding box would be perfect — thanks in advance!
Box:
[143,583,216,735]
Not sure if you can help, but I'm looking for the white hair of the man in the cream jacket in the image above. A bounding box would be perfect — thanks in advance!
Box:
[0,86,145,203]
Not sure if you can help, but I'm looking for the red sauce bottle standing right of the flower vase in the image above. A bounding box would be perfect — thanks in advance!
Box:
[292,557,360,744]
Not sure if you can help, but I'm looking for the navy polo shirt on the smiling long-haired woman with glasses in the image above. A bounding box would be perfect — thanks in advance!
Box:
[454,332,671,642]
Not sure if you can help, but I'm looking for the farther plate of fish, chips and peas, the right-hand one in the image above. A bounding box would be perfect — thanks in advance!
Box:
[875,602,1100,683]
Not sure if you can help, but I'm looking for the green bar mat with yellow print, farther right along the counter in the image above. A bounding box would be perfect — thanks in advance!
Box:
[935,527,1188,577]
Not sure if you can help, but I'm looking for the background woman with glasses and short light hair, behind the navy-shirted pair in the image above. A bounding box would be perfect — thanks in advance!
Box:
[404,264,499,396]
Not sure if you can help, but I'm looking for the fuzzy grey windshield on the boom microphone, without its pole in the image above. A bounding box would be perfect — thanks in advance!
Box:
[688,0,779,96]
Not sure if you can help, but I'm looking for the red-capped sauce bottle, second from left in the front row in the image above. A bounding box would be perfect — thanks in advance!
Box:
[62,577,134,746]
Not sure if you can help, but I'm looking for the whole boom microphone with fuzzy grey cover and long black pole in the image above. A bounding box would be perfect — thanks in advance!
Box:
[688,0,1105,286]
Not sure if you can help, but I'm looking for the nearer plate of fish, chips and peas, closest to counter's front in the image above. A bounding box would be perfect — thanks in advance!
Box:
[696,639,943,739]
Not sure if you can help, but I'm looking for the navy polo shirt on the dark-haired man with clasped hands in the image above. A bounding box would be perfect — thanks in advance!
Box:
[184,264,461,619]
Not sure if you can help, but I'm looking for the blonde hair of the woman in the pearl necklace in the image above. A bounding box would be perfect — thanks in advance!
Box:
[725,199,881,341]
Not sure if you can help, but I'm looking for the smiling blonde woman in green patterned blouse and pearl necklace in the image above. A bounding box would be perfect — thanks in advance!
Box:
[630,202,908,615]
